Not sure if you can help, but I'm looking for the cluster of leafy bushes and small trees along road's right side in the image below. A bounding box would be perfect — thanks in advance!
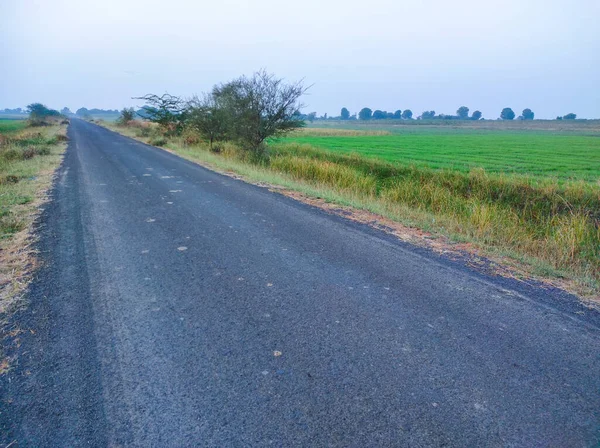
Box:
[120,70,307,152]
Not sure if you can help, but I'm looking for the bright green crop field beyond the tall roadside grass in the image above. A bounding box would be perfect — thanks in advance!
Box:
[285,127,600,182]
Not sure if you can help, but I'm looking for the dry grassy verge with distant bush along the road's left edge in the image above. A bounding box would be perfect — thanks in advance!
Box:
[0,104,67,315]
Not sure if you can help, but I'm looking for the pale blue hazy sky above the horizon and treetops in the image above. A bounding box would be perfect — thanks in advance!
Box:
[0,0,600,118]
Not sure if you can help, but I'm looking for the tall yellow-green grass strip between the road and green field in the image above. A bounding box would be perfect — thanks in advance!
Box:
[110,121,600,288]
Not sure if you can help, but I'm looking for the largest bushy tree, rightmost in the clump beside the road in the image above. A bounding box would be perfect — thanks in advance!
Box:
[212,70,307,151]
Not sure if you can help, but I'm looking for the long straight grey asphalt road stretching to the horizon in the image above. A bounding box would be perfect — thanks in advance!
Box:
[0,120,600,447]
